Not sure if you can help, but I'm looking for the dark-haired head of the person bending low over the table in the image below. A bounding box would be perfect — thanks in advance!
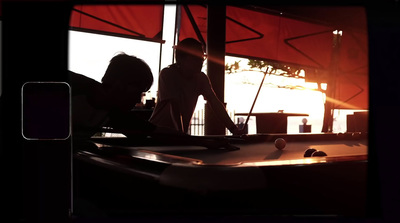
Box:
[101,53,153,110]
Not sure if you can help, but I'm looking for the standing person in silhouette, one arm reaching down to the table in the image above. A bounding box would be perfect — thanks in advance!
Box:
[149,38,244,135]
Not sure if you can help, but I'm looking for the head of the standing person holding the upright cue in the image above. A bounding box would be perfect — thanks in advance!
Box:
[175,38,206,72]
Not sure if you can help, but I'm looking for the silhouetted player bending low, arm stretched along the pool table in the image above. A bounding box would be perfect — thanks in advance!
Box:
[69,53,231,148]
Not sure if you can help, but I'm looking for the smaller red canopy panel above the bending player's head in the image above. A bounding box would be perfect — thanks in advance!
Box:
[70,4,164,42]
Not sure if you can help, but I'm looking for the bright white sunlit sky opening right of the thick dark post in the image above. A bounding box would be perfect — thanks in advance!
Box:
[225,57,324,133]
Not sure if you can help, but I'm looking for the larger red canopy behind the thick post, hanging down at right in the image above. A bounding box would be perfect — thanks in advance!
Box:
[179,5,368,109]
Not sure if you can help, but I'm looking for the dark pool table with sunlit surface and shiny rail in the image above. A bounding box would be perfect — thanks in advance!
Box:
[74,133,368,216]
